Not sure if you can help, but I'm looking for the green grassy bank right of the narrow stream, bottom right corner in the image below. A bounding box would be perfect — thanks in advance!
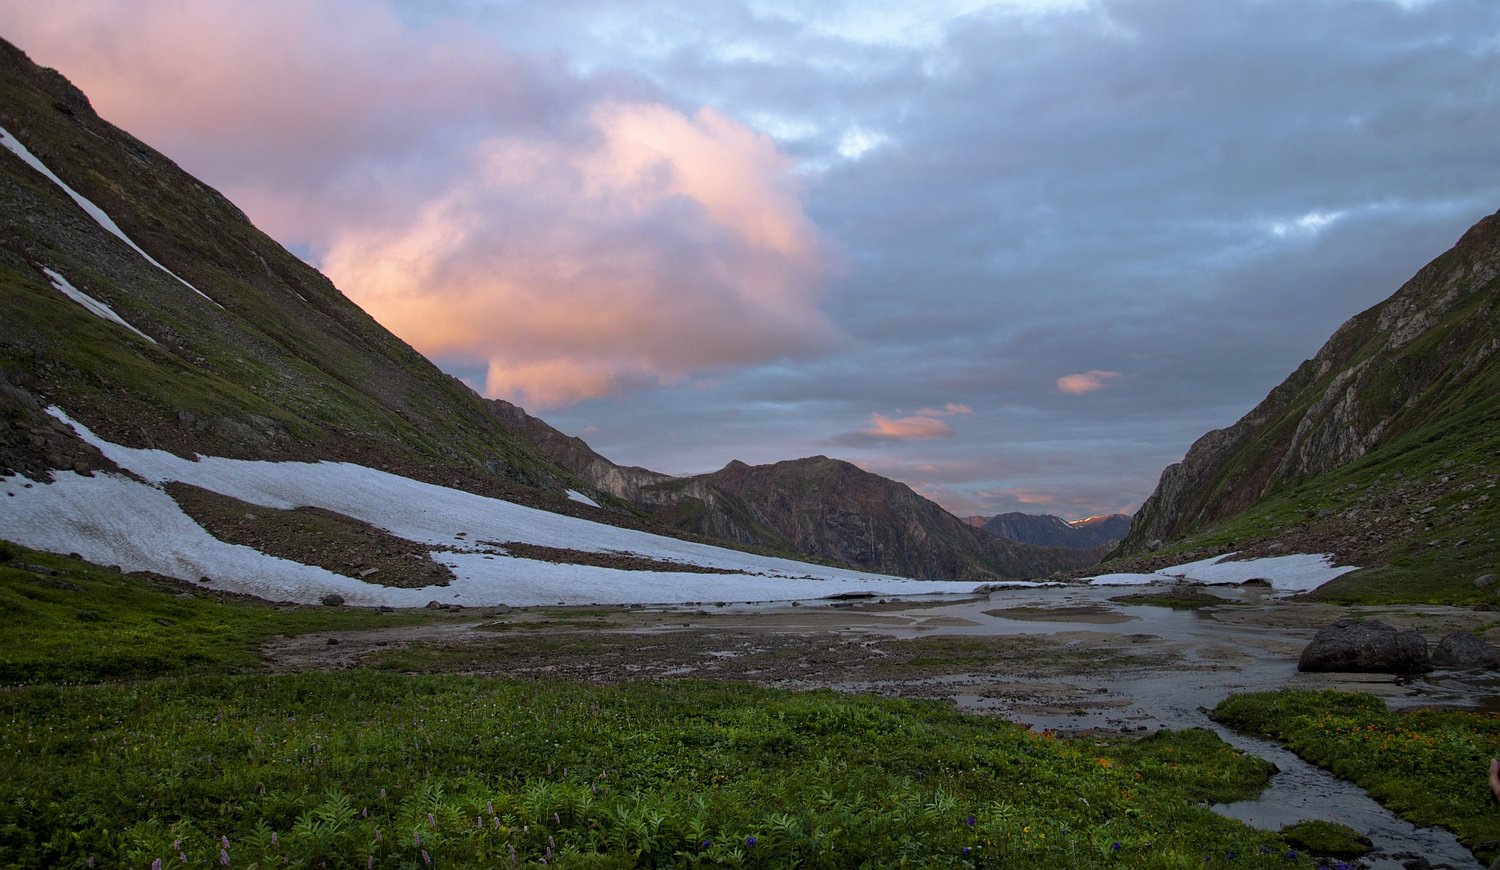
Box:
[1214,690,1500,861]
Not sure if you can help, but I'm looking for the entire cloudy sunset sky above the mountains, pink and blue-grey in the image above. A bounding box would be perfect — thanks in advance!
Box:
[0,0,1500,519]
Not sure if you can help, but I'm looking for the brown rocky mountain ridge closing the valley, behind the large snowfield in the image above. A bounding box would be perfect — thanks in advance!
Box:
[491,401,1103,581]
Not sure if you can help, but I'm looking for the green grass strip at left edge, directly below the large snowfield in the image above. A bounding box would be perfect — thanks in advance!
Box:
[0,545,431,684]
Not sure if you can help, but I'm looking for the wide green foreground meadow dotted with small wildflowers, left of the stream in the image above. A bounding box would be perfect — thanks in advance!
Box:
[0,671,1286,867]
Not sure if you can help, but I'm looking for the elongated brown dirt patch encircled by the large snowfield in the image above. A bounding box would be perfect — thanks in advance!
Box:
[164,483,455,590]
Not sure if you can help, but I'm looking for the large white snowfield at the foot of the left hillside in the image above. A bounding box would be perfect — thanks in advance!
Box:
[0,408,980,608]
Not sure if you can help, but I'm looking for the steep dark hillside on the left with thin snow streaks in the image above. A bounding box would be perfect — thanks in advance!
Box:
[0,42,578,510]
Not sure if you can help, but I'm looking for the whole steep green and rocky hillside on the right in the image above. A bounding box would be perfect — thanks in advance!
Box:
[1119,215,1500,600]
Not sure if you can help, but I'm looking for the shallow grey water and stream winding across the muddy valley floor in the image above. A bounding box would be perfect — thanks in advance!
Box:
[867,587,1500,869]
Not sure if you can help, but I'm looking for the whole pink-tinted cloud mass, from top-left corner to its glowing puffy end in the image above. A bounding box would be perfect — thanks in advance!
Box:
[0,0,836,408]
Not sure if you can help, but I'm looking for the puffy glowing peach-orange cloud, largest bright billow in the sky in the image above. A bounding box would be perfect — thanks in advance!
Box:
[324,102,836,408]
